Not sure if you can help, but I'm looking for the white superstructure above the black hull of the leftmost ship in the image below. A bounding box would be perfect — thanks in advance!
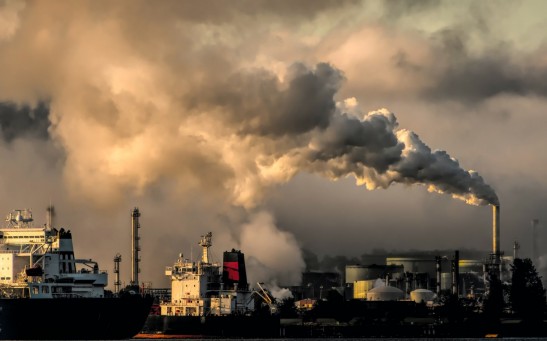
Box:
[0,208,108,298]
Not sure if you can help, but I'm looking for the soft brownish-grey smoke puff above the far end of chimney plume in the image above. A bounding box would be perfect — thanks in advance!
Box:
[193,63,343,136]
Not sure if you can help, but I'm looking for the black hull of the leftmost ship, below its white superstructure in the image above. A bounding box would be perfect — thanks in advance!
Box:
[0,295,152,340]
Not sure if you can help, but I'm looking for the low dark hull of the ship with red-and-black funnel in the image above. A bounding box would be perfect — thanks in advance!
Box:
[142,315,280,338]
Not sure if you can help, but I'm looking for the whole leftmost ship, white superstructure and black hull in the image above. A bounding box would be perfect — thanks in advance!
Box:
[0,207,152,340]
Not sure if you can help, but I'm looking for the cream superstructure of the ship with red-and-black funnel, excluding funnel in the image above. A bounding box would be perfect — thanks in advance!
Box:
[160,232,254,316]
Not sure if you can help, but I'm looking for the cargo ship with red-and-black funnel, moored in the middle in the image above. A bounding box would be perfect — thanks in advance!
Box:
[139,232,280,338]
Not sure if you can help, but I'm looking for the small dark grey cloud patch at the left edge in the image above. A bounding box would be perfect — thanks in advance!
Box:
[0,103,50,143]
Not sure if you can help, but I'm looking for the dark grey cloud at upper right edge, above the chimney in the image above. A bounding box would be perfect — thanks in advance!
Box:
[425,29,547,103]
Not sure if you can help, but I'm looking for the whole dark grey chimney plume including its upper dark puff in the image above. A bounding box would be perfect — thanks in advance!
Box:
[186,63,497,205]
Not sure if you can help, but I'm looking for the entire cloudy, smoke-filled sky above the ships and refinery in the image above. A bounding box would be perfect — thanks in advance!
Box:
[0,0,547,287]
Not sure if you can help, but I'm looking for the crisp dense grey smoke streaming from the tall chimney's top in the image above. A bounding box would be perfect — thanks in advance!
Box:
[306,103,498,205]
